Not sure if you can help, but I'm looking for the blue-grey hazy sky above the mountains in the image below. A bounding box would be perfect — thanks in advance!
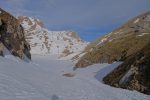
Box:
[0,0,150,41]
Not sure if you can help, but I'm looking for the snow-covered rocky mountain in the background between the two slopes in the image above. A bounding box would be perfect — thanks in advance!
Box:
[18,16,87,55]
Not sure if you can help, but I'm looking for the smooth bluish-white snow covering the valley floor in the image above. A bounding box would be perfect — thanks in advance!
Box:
[0,56,150,100]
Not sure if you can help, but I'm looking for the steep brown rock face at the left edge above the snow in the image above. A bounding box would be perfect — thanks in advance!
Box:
[0,9,31,59]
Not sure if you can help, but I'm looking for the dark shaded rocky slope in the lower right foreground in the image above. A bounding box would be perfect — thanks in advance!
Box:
[103,43,150,94]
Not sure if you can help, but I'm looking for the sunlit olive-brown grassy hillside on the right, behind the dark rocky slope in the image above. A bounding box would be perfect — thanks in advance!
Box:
[76,11,150,68]
